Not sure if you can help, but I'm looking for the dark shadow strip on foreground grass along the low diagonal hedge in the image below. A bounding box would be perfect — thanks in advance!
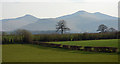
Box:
[23,44,117,55]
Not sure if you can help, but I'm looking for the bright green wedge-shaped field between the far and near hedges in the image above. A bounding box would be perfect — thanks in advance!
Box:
[46,39,118,47]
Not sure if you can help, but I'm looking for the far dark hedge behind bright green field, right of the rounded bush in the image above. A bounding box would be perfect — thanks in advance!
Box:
[33,33,118,42]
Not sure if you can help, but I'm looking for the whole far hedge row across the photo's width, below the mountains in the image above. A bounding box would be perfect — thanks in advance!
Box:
[2,33,118,44]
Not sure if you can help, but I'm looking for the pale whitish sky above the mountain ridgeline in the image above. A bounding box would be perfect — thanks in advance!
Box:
[0,0,119,19]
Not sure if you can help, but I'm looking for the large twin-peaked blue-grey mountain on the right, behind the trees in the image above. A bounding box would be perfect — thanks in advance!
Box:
[58,11,118,32]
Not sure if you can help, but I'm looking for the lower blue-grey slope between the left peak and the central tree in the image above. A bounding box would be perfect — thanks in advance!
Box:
[21,18,59,31]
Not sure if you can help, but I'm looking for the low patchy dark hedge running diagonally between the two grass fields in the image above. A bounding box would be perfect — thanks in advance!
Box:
[32,41,118,53]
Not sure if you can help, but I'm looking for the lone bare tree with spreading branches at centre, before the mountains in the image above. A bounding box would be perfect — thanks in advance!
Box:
[56,20,70,34]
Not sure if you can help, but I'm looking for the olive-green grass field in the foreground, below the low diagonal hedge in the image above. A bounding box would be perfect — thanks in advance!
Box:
[2,44,118,62]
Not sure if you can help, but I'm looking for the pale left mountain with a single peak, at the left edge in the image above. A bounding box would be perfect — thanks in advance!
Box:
[2,14,39,31]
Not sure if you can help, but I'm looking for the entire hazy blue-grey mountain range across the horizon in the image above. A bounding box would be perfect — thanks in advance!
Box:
[2,11,118,32]
